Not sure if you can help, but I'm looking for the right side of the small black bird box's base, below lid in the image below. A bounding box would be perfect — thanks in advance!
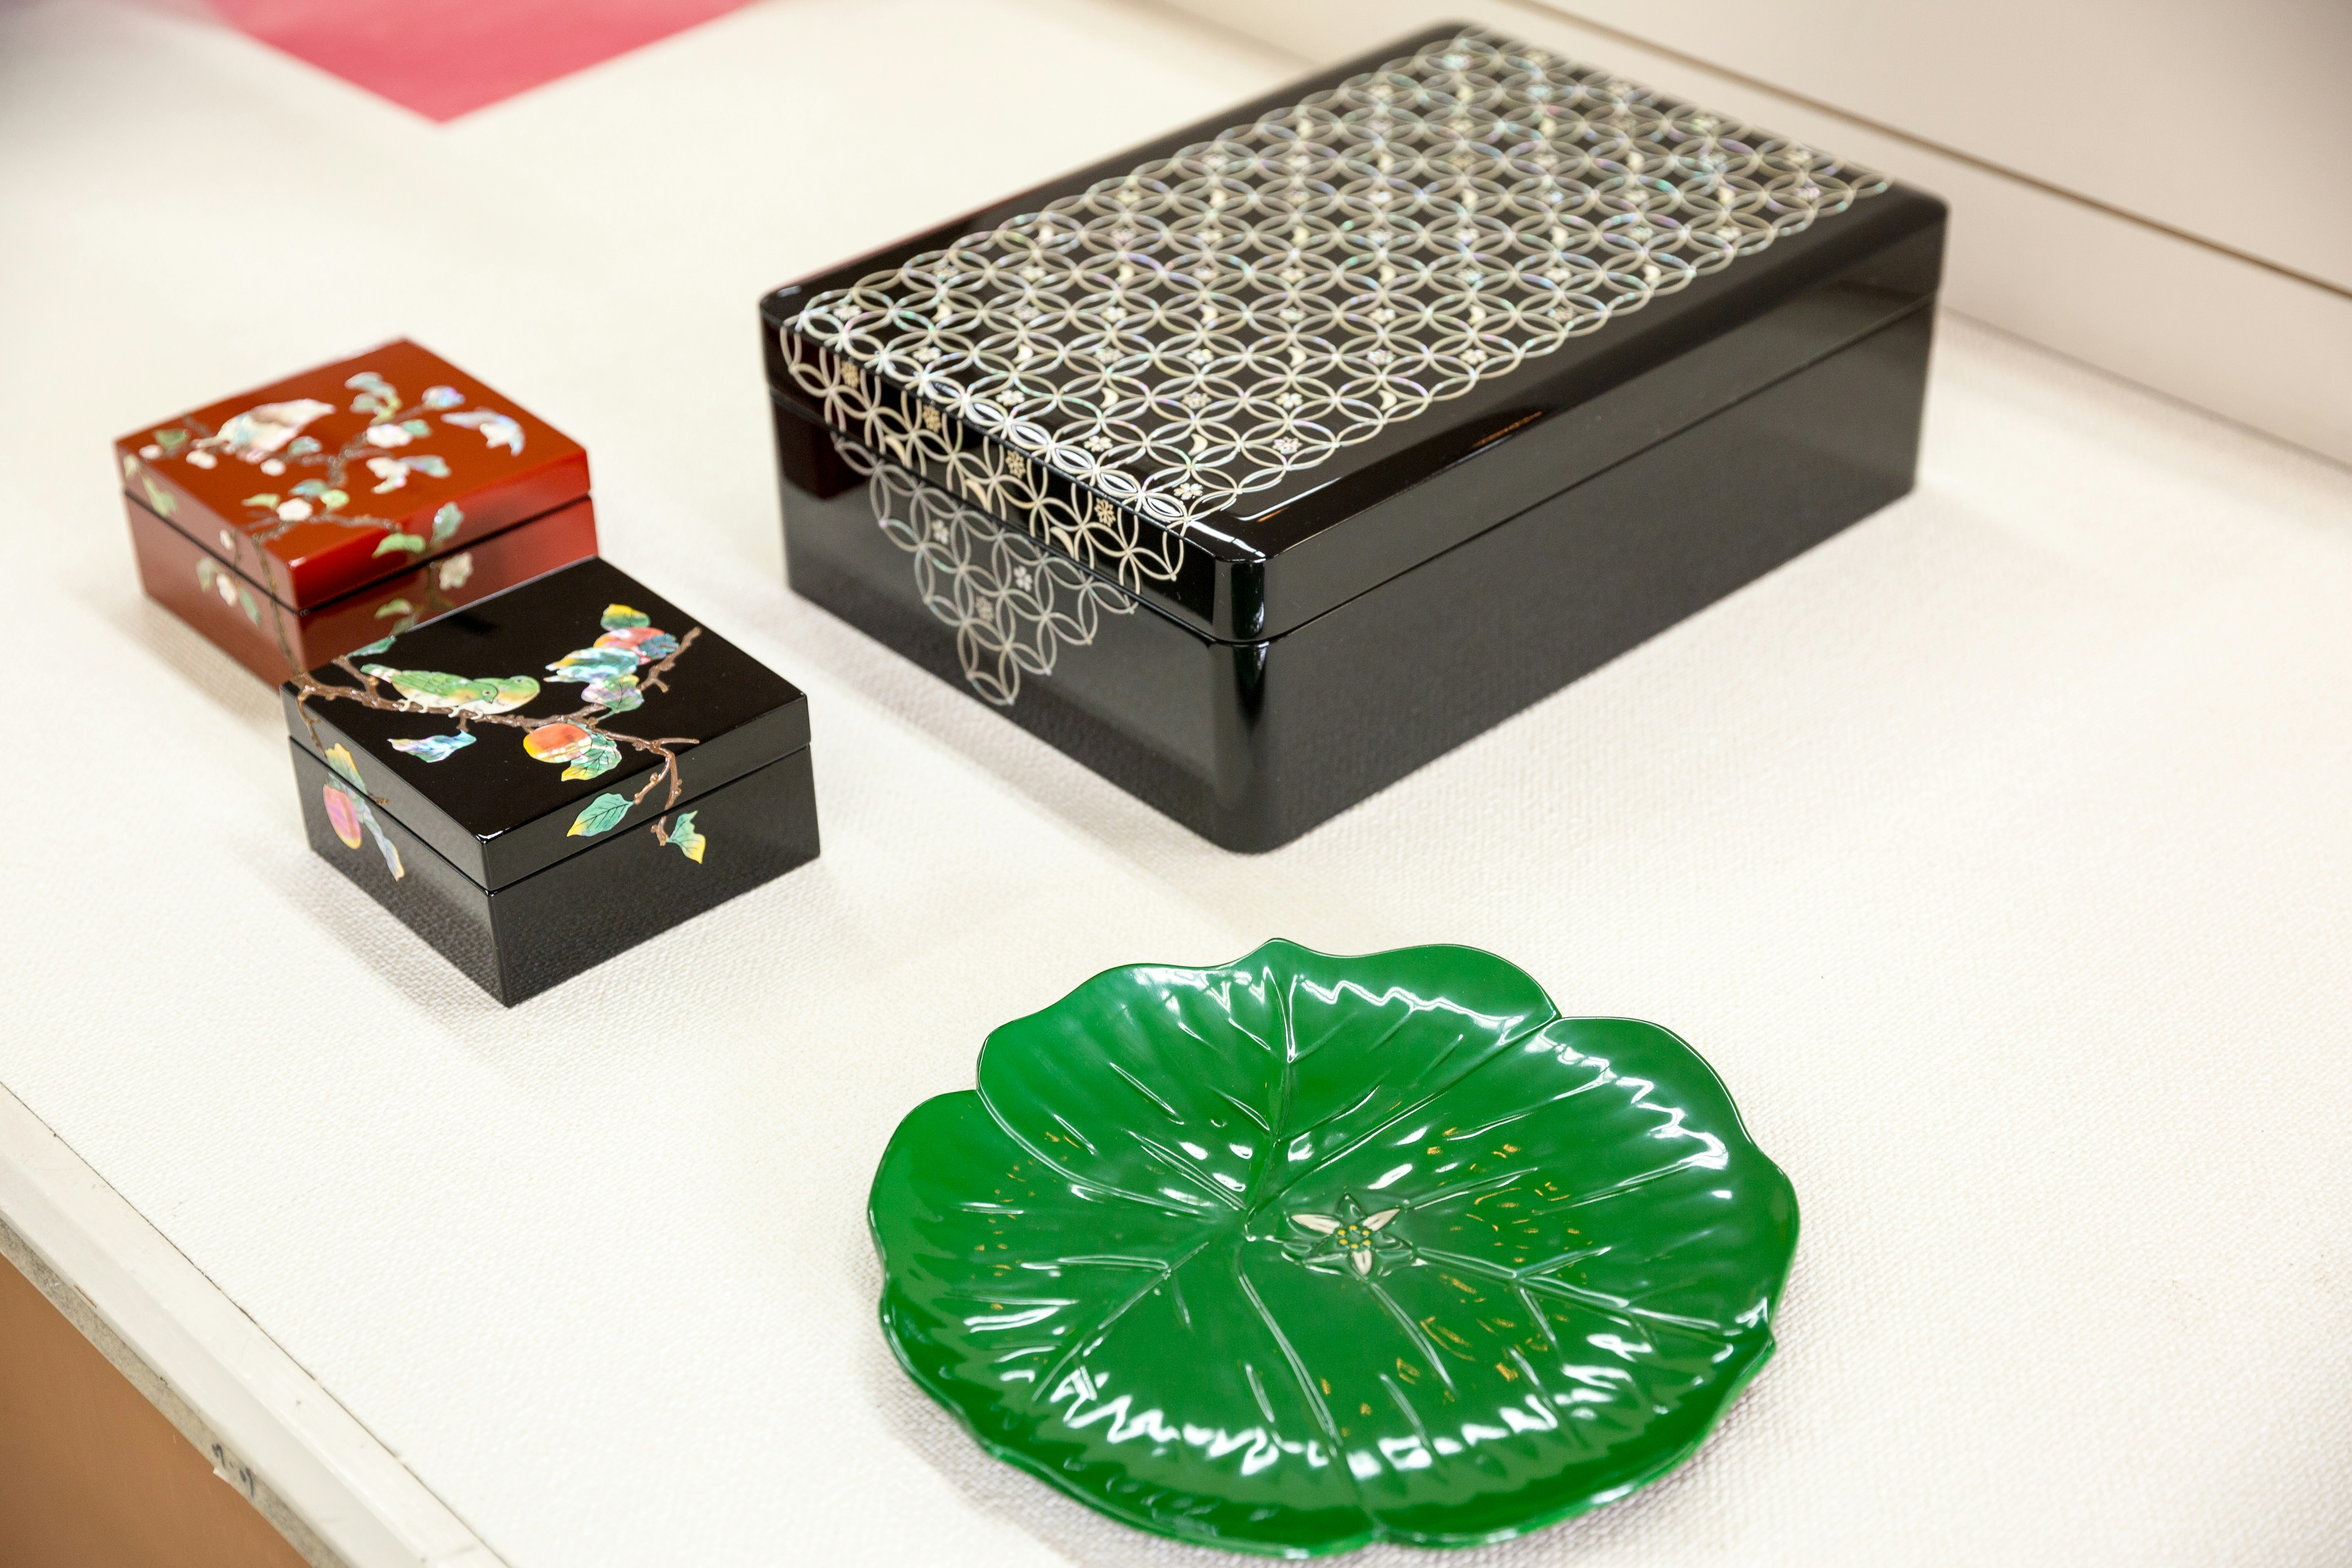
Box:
[489,748,818,1006]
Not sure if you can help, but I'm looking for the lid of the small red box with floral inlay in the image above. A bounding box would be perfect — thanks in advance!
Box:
[115,339,588,609]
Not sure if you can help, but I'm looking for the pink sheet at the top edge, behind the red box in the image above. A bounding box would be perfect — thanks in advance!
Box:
[212,0,743,120]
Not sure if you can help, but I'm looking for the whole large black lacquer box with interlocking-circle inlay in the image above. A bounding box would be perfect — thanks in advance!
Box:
[762,28,1945,849]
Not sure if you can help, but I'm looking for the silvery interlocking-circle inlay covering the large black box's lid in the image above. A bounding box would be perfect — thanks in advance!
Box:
[783,31,1886,583]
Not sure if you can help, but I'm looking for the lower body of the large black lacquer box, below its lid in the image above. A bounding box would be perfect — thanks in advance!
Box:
[779,308,1933,851]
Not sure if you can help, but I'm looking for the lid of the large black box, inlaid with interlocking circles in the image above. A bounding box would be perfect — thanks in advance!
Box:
[762,26,1943,639]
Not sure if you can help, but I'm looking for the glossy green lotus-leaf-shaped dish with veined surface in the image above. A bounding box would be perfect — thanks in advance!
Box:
[868,943,1797,1556]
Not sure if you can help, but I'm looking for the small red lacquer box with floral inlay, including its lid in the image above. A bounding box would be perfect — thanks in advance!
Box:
[115,341,597,682]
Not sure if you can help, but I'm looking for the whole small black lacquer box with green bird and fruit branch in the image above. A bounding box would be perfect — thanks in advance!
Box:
[280,559,816,1006]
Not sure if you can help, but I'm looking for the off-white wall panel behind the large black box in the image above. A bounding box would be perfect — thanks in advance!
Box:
[1174,0,2352,463]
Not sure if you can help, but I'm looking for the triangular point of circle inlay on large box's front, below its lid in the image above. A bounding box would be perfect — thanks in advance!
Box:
[835,437,1136,708]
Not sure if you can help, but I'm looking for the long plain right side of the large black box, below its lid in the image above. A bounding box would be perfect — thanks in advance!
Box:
[1251,310,1933,849]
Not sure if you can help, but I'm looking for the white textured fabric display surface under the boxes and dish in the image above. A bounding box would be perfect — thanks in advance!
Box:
[0,0,2352,1568]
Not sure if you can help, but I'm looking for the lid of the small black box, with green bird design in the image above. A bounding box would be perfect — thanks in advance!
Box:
[280,559,809,889]
